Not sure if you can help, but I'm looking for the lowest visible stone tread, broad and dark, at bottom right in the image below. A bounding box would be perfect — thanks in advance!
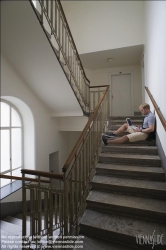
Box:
[81,209,166,244]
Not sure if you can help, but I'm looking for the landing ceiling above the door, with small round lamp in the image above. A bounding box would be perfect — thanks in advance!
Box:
[80,45,144,70]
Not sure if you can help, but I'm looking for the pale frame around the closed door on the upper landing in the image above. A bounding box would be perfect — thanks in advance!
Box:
[109,71,134,116]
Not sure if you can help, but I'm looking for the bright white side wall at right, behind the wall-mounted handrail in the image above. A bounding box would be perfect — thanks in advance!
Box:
[145,1,166,170]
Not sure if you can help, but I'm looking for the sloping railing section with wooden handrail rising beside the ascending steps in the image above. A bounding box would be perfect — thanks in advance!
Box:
[62,86,109,235]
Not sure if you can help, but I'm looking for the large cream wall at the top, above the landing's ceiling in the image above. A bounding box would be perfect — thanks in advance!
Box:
[62,1,144,54]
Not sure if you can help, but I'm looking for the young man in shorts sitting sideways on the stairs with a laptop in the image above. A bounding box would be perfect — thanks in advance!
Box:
[102,103,155,145]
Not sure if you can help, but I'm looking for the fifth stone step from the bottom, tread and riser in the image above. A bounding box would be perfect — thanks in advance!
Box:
[99,153,161,167]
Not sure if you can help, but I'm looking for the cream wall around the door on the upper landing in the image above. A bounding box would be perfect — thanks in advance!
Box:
[85,65,142,112]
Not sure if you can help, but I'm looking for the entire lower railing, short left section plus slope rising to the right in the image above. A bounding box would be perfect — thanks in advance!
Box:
[21,86,109,246]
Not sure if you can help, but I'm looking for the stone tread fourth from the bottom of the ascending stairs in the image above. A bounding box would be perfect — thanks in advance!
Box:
[96,163,164,174]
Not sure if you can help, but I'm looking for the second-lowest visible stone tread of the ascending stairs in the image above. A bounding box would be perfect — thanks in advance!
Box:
[87,190,166,215]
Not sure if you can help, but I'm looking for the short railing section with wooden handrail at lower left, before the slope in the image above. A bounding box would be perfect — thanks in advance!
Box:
[21,169,64,249]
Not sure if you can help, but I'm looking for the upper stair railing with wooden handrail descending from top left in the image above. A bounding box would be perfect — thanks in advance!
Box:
[30,0,90,114]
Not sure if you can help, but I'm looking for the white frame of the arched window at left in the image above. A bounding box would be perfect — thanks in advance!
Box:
[0,99,24,185]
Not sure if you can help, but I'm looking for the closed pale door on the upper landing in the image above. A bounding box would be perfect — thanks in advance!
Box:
[110,74,132,116]
